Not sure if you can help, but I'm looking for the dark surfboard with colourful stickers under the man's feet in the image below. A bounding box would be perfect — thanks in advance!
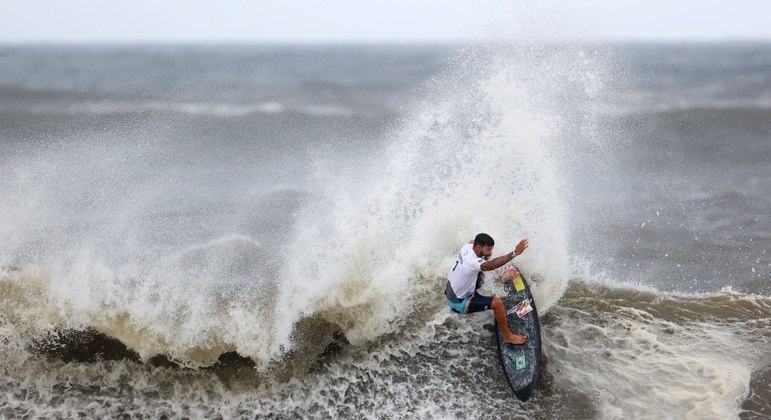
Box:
[495,273,541,401]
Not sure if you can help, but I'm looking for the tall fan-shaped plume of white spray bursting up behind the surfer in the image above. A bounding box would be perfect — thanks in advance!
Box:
[276,48,616,360]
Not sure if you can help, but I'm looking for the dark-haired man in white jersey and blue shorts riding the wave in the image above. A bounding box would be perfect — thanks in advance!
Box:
[444,233,528,345]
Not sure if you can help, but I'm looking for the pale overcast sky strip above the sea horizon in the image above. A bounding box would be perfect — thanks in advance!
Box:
[0,0,771,43]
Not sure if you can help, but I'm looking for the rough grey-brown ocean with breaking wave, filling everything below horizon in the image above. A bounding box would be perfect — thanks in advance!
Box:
[0,43,771,419]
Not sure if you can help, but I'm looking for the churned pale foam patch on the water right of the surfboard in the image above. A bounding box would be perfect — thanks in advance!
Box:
[544,292,757,419]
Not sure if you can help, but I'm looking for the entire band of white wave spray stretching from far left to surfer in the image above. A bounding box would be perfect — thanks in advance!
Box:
[0,47,616,370]
